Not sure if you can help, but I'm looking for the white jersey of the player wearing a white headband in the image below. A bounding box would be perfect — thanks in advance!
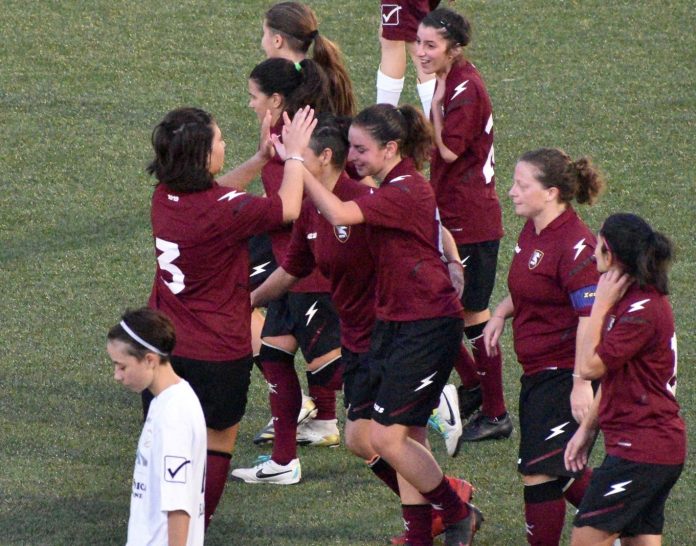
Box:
[127,379,207,546]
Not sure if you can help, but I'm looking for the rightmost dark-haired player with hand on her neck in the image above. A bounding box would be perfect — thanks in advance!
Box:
[565,214,686,546]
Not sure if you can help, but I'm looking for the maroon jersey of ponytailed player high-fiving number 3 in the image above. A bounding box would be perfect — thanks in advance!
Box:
[355,158,462,321]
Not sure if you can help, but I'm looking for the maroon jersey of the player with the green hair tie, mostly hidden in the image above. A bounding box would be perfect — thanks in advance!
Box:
[261,118,331,292]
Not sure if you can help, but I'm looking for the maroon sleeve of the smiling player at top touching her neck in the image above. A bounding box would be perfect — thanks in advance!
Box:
[442,82,480,156]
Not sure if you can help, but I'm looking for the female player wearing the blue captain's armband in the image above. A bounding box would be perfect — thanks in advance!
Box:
[483,148,604,546]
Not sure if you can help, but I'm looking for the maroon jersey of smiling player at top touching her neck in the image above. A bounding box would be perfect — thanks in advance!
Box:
[430,61,503,244]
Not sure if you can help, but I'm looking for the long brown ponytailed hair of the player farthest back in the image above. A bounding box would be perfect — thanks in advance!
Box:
[265,2,356,116]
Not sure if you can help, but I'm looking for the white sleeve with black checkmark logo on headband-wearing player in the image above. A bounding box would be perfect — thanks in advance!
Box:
[158,411,201,517]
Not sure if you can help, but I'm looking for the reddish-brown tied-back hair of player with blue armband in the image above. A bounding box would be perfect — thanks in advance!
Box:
[519,148,606,205]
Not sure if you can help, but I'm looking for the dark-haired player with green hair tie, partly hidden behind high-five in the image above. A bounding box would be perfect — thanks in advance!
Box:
[232,57,343,485]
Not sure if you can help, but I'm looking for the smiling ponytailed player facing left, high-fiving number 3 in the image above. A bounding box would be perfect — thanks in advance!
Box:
[305,104,482,545]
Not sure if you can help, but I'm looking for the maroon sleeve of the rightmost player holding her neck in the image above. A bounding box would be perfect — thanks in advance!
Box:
[597,313,655,370]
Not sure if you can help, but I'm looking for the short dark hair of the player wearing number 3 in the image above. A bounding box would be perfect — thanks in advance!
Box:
[147,108,215,193]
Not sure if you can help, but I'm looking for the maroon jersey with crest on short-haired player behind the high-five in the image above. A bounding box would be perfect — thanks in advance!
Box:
[283,173,375,353]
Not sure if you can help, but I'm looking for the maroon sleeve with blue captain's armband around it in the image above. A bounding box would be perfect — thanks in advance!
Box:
[560,243,599,317]
